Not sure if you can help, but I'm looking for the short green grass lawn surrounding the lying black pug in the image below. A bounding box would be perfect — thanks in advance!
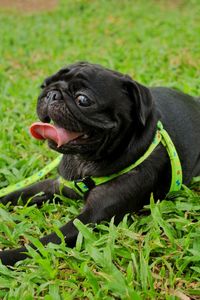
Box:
[0,0,200,300]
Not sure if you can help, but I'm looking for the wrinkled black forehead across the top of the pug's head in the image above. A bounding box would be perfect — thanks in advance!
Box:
[42,62,123,88]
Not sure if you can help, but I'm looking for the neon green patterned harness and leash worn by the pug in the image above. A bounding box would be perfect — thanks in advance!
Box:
[0,121,182,197]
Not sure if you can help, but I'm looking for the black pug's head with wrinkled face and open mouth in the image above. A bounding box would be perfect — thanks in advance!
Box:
[34,62,152,158]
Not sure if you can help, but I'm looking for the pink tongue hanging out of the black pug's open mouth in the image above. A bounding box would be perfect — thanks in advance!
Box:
[30,122,82,147]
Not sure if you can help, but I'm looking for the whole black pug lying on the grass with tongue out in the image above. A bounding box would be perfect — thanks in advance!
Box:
[0,62,200,265]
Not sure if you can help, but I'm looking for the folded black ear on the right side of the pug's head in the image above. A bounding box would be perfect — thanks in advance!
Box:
[123,75,153,126]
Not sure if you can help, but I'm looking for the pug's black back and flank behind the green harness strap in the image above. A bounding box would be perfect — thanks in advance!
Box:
[151,87,200,184]
